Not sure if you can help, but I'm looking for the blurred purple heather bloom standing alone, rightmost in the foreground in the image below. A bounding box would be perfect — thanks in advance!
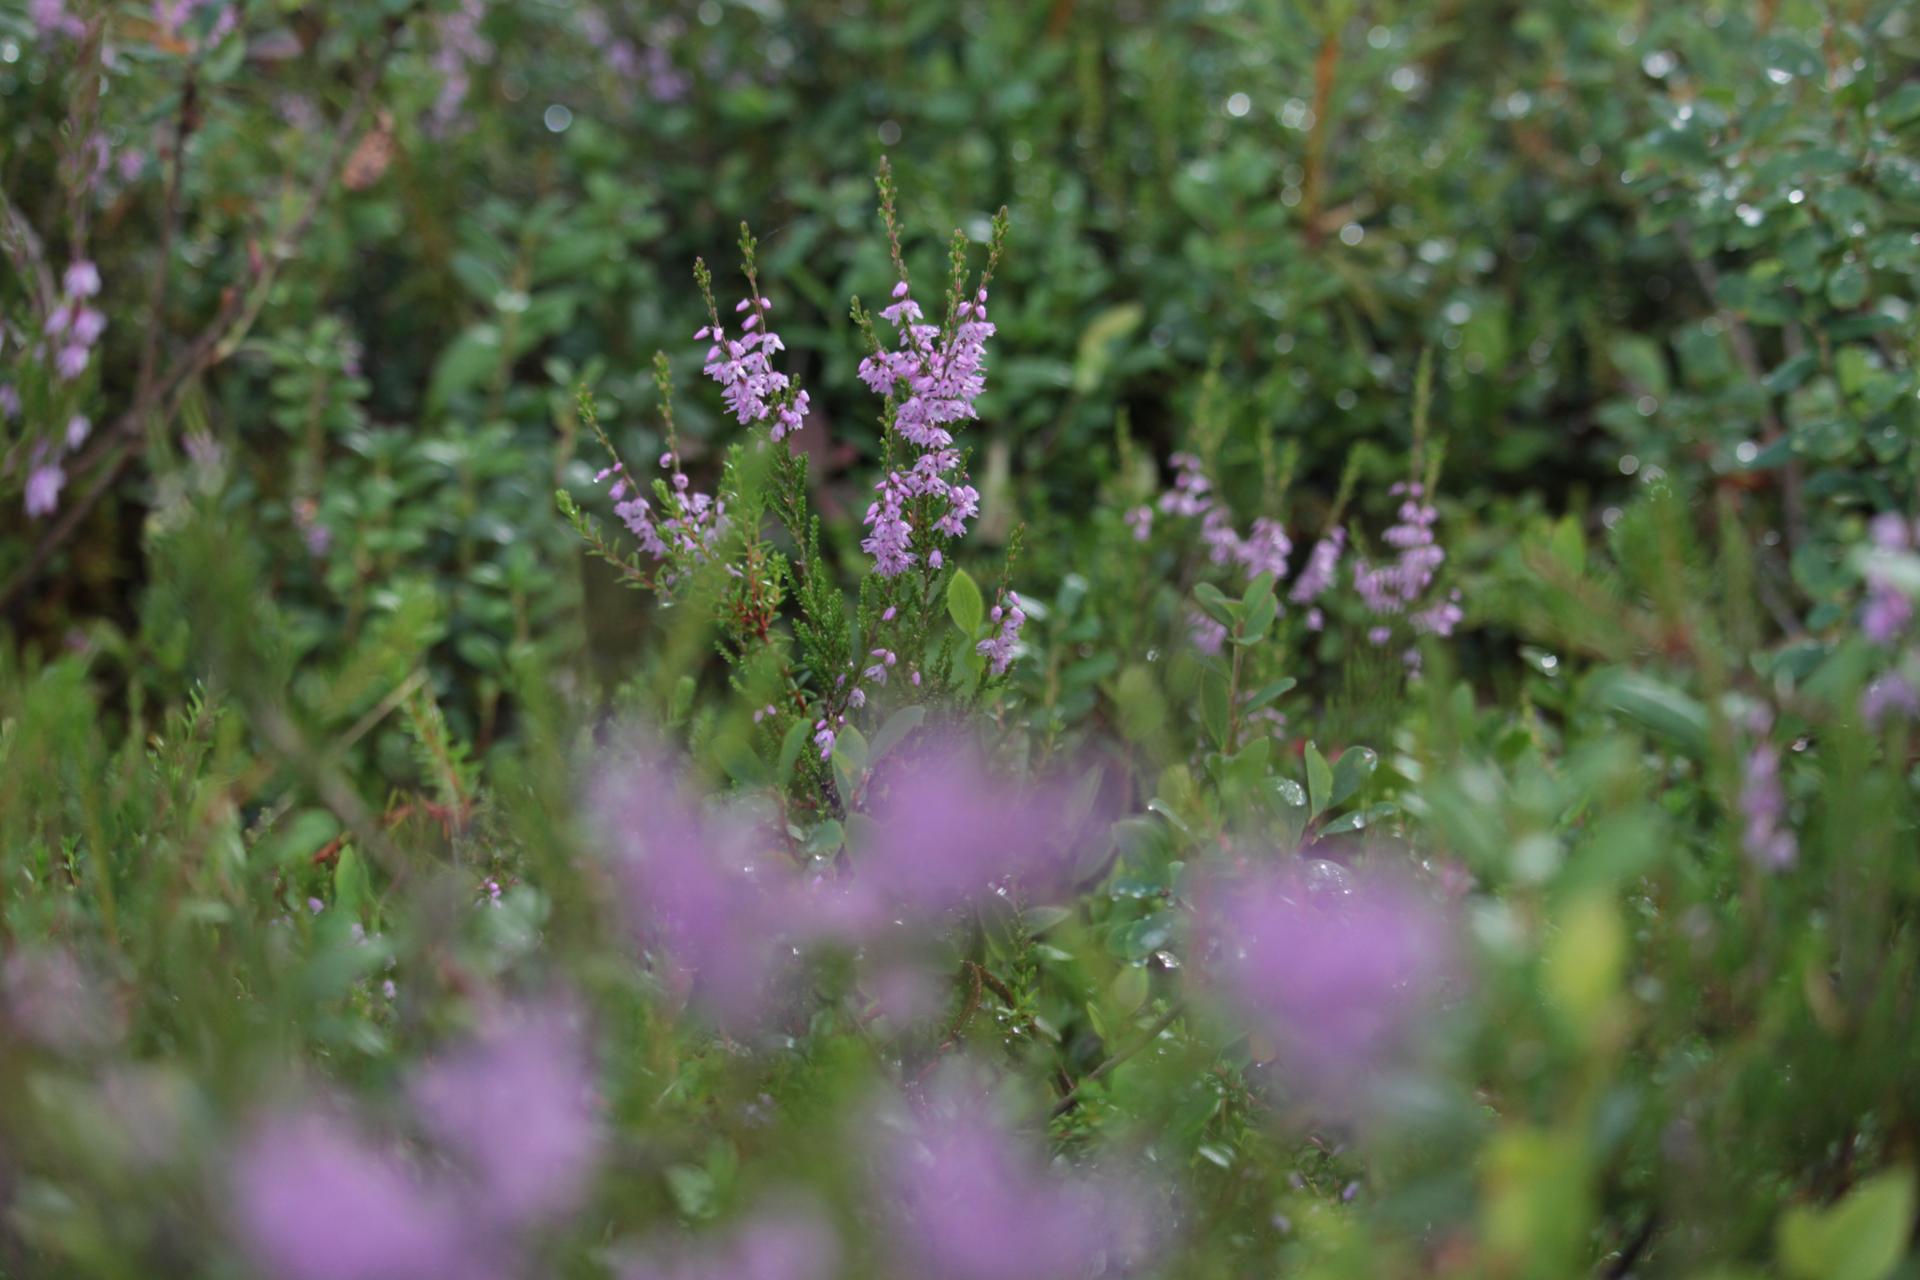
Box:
[1198,860,1455,1107]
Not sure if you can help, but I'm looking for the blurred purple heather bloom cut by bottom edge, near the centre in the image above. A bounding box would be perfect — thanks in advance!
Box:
[879,1084,1156,1280]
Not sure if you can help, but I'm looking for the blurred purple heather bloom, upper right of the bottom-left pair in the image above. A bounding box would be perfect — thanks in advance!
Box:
[409,1005,603,1224]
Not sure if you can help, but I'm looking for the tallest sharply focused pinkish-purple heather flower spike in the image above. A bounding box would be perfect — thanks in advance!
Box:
[860,276,995,578]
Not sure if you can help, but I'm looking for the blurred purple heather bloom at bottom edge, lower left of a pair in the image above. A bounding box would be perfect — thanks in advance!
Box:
[227,1100,476,1280]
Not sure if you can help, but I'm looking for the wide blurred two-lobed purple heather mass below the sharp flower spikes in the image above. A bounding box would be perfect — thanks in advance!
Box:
[588,735,1106,1031]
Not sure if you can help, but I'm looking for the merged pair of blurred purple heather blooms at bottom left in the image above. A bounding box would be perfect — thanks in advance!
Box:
[228,1006,603,1280]
